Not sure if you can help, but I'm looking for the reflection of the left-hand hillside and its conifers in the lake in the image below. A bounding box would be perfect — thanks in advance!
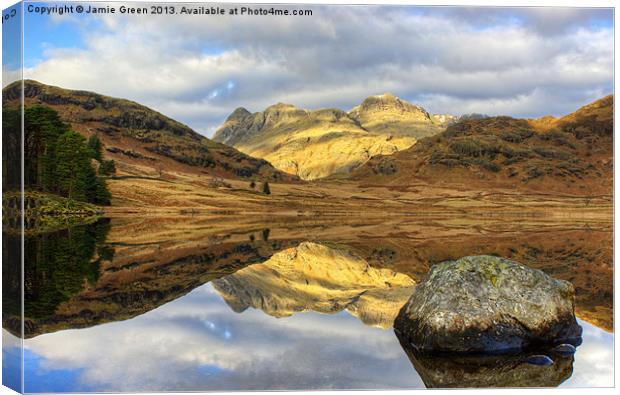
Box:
[3,221,299,337]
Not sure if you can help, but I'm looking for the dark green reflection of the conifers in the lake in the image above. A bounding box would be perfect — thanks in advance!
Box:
[3,219,114,338]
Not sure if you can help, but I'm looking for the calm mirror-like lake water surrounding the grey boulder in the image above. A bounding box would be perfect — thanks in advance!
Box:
[3,220,614,392]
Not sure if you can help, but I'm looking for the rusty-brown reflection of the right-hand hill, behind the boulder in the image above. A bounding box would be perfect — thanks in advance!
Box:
[346,227,613,331]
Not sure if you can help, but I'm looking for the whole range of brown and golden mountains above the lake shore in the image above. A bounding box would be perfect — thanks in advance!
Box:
[3,80,614,206]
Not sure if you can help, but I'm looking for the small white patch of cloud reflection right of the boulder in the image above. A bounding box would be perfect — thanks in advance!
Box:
[563,320,614,387]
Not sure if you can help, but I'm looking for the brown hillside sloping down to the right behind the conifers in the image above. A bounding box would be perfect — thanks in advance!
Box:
[2,80,295,186]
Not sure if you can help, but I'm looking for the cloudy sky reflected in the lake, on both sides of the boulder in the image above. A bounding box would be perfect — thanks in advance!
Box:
[15,284,613,391]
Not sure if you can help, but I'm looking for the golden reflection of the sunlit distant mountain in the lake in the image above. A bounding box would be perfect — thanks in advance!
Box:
[213,242,415,328]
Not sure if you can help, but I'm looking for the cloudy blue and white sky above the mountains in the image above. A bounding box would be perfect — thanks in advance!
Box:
[3,3,614,136]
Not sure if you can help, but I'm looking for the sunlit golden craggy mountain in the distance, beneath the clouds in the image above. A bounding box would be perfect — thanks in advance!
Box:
[213,93,449,180]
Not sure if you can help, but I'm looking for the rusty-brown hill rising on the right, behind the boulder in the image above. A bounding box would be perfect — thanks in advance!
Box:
[352,96,613,195]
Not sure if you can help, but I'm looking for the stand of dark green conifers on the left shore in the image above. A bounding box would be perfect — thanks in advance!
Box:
[2,105,116,205]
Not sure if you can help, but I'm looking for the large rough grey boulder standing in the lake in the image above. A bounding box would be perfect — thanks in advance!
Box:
[394,256,581,353]
